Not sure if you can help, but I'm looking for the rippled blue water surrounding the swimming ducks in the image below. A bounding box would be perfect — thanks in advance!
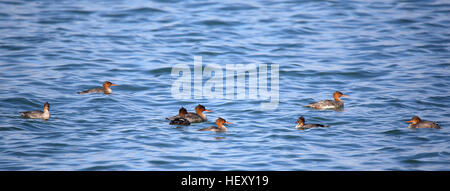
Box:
[0,0,450,170]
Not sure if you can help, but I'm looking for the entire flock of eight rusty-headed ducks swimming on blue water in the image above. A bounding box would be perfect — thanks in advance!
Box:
[20,81,440,132]
